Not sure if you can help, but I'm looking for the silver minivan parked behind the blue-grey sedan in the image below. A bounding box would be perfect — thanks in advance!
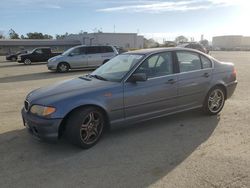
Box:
[47,45,118,72]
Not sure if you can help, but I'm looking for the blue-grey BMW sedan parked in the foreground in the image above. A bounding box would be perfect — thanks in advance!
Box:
[22,48,237,148]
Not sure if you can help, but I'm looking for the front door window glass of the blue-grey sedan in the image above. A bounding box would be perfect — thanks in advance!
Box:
[136,52,173,78]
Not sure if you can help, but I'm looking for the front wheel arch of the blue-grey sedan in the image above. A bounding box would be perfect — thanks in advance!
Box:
[58,104,110,138]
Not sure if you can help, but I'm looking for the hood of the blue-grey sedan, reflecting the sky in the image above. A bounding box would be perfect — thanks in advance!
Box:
[26,77,117,103]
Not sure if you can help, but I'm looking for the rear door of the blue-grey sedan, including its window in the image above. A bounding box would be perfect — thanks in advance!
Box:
[176,51,212,109]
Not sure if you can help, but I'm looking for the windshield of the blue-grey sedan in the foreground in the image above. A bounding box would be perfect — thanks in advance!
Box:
[91,54,143,82]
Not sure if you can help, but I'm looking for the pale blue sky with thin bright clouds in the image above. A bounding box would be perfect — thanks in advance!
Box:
[0,0,250,42]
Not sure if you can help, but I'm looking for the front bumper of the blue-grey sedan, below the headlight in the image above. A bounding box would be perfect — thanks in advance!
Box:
[22,109,62,141]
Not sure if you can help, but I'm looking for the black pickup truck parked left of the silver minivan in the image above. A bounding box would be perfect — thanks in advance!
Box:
[17,47,61,65]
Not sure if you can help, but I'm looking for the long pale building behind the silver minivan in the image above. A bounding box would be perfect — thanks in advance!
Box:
[67,32,144,49]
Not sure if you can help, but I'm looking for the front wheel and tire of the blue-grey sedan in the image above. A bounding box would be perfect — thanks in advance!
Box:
[65,107,105,149]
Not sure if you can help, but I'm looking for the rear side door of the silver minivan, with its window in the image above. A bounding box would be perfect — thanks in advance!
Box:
[86,46,103,67]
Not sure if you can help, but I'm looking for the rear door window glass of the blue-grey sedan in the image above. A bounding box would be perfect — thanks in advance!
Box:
[176,52,201,72]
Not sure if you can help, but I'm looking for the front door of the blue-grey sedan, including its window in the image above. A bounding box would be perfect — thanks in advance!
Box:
[124,52,177,119]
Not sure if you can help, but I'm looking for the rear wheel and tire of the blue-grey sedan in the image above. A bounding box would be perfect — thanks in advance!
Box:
[203,86,225,115]
